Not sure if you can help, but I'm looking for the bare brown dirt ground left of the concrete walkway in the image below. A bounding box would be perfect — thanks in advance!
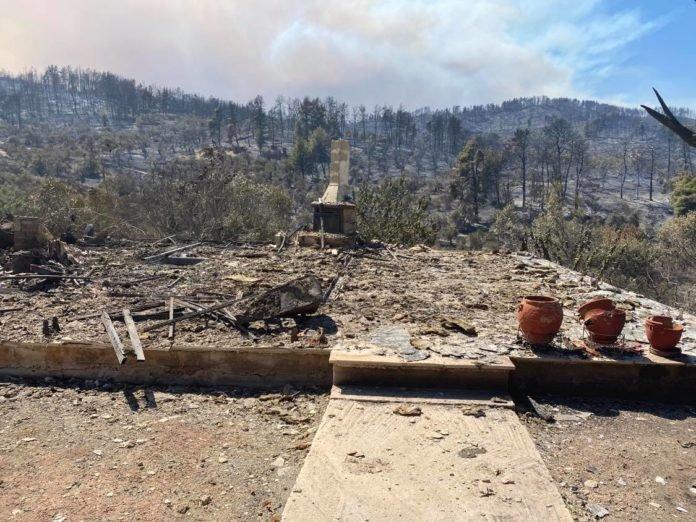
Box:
[0,379,328,522]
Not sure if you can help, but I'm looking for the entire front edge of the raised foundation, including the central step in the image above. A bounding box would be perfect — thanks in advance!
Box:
[0,342,696,402]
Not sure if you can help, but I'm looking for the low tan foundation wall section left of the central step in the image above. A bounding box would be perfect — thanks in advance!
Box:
[0,343,331,387]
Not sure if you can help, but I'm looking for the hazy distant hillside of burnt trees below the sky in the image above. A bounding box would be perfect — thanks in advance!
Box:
[0,66,693,189]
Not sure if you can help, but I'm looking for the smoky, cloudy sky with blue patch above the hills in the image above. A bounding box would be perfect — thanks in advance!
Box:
[0,0,696,109]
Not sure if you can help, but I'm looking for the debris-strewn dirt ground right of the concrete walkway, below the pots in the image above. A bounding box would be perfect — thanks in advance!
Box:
[521,397,696,521]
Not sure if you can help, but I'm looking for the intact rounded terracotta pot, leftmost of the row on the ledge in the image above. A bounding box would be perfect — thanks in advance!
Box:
[517,295,563,344]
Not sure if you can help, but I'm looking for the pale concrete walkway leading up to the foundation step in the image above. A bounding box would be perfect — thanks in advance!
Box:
[283,387,572,522]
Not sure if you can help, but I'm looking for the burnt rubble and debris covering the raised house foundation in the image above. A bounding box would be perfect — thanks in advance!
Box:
[0,233,696,362]
